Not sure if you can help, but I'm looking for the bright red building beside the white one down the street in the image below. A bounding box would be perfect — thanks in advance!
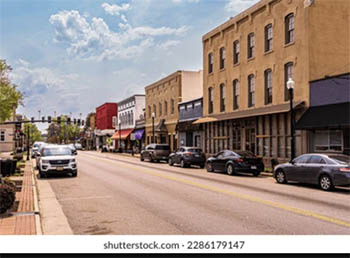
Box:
[95,102,118,149]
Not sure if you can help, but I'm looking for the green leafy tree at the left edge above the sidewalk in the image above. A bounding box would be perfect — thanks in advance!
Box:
[0,60,23,122]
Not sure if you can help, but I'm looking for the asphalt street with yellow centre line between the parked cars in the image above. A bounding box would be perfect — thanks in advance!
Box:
[43,151,350,235]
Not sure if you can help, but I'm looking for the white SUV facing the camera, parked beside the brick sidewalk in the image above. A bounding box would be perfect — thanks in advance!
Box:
[39,145,78,177]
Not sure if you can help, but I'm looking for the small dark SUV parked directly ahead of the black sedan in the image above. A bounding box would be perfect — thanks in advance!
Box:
[168,147,205,168]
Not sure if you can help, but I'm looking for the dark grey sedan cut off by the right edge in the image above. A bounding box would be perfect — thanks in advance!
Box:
[274,153,350,191]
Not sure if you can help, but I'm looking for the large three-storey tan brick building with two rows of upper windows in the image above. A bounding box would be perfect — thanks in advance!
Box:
[195,0,350,165]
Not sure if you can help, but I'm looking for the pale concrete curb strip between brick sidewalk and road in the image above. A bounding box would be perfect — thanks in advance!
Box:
[33,160,73,235]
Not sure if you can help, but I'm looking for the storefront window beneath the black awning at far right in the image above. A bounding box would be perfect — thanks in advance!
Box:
[314,130,343,152]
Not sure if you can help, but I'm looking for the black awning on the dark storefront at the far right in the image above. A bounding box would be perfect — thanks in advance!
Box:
[295,102,350,130]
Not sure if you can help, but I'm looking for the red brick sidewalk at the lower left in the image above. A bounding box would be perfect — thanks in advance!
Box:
[0,161,41,235]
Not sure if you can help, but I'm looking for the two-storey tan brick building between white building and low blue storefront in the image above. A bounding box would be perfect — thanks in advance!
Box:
[145,71,203,150]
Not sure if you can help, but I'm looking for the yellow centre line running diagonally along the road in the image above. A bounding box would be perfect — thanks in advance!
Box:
[80,155,350,228]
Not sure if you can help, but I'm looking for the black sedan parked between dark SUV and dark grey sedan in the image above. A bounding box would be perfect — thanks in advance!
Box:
[207,150,264,176]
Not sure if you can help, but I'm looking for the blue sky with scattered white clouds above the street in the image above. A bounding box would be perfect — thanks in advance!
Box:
[0,0,258,130]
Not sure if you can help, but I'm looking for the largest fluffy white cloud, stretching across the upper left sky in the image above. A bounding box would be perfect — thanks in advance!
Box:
[49,10,189,61]
